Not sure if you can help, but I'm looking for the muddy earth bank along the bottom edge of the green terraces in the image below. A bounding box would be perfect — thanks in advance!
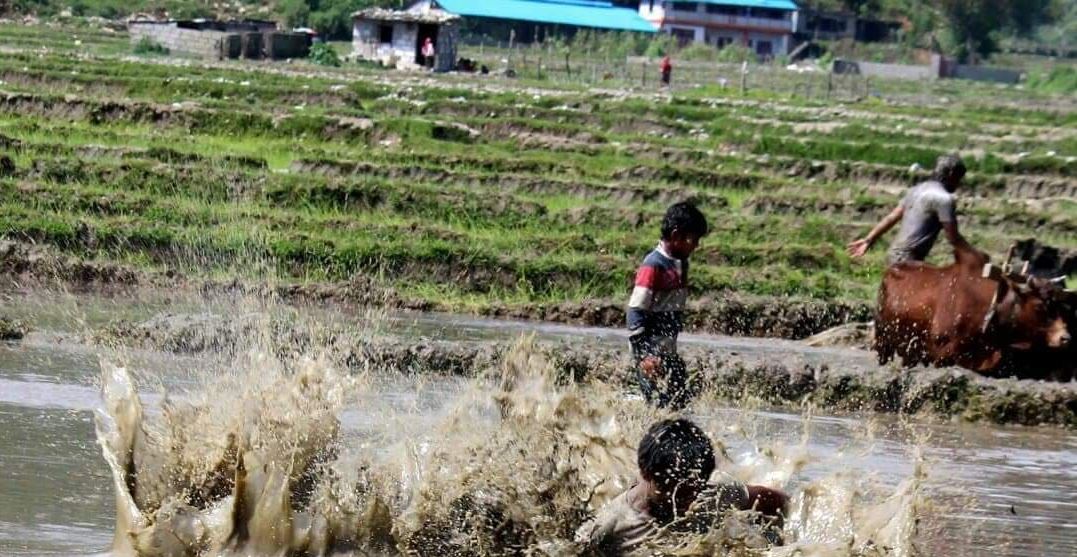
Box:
[0,240,873,339]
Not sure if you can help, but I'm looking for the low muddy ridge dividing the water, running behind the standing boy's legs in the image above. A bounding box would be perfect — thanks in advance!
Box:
[67,314,1077,428]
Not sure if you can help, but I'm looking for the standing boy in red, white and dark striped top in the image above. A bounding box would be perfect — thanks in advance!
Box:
[627,203,707,408]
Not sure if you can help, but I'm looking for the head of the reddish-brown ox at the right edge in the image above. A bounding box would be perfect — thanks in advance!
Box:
[999,283,1075,350]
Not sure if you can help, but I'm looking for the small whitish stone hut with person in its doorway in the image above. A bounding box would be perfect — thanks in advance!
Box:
[352,8,460,71]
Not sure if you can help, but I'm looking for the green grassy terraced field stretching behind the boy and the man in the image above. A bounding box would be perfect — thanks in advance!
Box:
[0,25,1077,336]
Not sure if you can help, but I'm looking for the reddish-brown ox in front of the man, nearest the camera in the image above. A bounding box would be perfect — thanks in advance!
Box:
[873,245,1072,374]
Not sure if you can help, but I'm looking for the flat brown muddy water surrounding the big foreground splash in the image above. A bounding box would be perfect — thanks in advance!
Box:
[0,303,1077,556]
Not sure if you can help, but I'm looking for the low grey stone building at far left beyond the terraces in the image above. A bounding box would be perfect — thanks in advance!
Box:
[127,19,310,60]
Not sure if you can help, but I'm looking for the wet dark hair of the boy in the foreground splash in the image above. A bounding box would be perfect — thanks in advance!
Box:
[637,418,714,487]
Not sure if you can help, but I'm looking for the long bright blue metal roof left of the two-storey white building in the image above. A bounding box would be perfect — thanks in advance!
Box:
[436,0,656,32]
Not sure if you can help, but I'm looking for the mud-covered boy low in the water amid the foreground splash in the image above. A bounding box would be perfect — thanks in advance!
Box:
[576,419,788,555]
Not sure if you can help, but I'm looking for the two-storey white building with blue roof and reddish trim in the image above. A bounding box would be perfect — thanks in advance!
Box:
[640,0,797,57]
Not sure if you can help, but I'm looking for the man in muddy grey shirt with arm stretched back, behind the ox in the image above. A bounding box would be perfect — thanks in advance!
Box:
[849,155,969,265]
